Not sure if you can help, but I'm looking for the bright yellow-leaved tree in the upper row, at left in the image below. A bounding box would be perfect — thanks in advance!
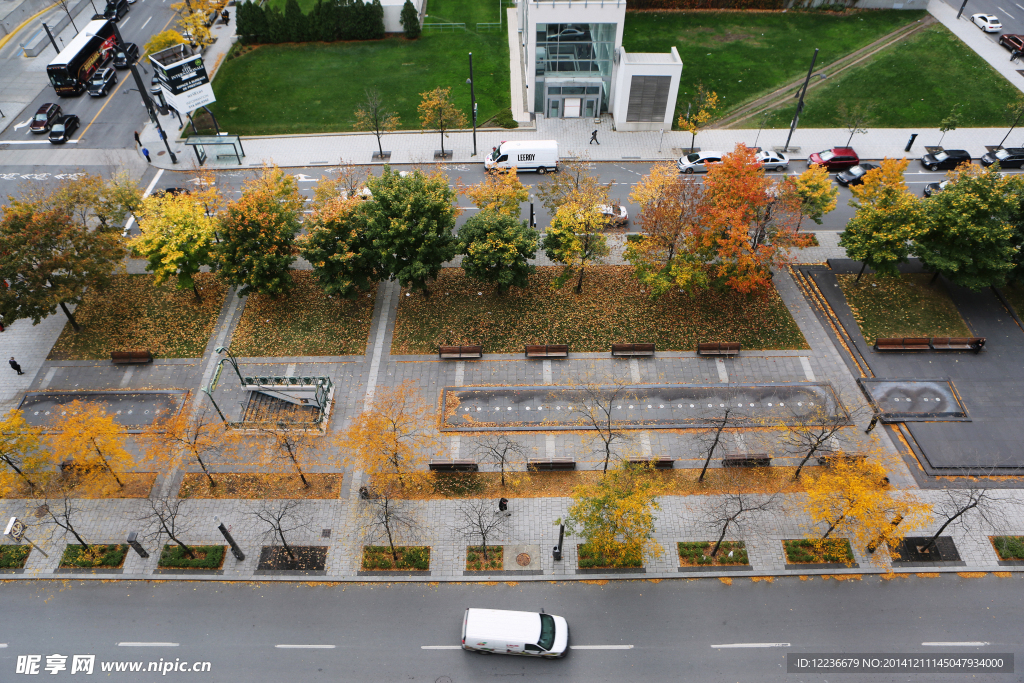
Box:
[131,173,220,301]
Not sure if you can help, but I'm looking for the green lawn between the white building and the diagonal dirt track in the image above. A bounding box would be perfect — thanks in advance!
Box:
[623,9,925,124]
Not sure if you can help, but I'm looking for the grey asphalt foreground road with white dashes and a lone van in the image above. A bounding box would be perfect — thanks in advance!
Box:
[0,574,1024,683]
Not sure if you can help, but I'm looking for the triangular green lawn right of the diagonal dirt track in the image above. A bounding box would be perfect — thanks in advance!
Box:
[769,26,1020,129]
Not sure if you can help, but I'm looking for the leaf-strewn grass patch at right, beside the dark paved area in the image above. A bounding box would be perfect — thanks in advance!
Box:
[837,272,971,344]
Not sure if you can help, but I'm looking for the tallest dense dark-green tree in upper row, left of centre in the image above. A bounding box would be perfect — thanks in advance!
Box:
[361,166,459,295]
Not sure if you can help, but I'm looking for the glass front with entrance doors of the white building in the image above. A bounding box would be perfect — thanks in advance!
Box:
[534,24,615,117]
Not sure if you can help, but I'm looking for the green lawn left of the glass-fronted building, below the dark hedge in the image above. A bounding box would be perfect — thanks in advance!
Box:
[211,0,510,136]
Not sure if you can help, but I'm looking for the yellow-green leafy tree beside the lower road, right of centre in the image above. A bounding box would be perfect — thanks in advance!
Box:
[565,462,663,565]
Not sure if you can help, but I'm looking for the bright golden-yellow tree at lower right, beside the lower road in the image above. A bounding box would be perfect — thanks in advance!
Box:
[802,457,930,561]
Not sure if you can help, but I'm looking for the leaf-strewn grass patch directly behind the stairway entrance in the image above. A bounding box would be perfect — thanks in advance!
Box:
[231,270,376,356]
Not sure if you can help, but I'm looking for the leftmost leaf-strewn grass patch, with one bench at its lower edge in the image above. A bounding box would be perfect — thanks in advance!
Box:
[49,272,227,360]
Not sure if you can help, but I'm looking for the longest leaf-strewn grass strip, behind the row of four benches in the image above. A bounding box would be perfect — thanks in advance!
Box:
[391,266,807,354]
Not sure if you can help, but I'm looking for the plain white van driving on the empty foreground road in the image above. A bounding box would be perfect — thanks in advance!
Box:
[462,607,569,657]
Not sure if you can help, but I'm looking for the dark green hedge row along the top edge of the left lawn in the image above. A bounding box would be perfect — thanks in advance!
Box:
[236,0,384,45]
